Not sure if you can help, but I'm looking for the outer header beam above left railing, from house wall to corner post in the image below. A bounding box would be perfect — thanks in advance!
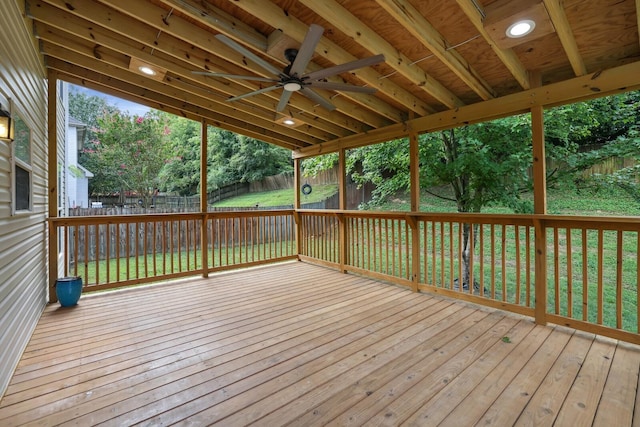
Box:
[47,57,299,150]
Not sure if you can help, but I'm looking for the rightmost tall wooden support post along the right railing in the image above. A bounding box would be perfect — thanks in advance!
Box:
[531,72,547,325]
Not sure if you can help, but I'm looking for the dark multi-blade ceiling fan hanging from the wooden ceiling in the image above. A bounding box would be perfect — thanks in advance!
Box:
[193,24,384,112]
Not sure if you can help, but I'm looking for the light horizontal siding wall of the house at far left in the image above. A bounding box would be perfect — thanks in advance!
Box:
[0,0,47,395]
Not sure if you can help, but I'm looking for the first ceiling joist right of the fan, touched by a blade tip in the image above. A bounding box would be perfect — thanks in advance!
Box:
[299,0,464,108]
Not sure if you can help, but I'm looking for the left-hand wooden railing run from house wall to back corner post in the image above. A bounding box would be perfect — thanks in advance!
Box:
[49,210,297,290]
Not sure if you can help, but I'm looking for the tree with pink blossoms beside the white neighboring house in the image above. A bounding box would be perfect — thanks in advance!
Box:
[85,111,169,207]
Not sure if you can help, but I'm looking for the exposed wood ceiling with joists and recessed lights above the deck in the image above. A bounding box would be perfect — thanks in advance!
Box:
[27,0,640,157]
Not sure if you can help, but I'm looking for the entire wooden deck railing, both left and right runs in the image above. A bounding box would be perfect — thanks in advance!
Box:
[50,210,640,343]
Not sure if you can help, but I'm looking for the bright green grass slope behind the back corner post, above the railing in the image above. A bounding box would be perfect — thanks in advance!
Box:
[211,184,338,208]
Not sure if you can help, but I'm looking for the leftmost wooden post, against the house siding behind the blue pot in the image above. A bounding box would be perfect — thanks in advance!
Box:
[47,69,59,302]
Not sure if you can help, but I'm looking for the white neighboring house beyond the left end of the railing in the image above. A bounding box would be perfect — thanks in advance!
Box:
[64,116,93,209]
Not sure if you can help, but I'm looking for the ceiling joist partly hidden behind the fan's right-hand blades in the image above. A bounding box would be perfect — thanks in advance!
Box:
[216,0,435,117]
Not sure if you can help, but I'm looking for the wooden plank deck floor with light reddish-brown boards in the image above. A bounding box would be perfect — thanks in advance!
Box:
[0,262,640,426]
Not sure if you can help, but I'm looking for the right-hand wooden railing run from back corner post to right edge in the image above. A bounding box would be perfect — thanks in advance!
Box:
[297,210,640,343]
